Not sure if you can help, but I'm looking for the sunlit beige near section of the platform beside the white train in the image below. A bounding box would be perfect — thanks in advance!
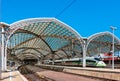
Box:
[63,67,120,81]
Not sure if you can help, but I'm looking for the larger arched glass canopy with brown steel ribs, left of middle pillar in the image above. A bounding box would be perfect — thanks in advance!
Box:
[7,18,83,60]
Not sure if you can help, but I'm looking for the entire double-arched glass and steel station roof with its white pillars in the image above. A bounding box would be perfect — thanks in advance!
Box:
[0,18,120,70]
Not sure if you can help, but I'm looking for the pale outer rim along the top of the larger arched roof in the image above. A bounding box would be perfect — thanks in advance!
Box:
[9,18,82,38]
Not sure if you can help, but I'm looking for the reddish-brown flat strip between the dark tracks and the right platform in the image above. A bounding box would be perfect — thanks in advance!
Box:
[26,65,103,81]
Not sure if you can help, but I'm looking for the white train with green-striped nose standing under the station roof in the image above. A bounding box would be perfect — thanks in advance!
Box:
[45,57,106,67]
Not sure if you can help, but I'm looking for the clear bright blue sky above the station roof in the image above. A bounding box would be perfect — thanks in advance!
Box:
[0,0,120,38]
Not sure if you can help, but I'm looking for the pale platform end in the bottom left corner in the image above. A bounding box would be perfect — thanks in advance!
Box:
[0,71,28,81]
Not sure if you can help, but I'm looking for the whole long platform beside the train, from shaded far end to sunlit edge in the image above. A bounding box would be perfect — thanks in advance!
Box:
[36,65,120,81]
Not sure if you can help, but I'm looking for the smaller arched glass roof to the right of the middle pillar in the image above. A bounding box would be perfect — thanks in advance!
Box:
[87,32,120,56]
